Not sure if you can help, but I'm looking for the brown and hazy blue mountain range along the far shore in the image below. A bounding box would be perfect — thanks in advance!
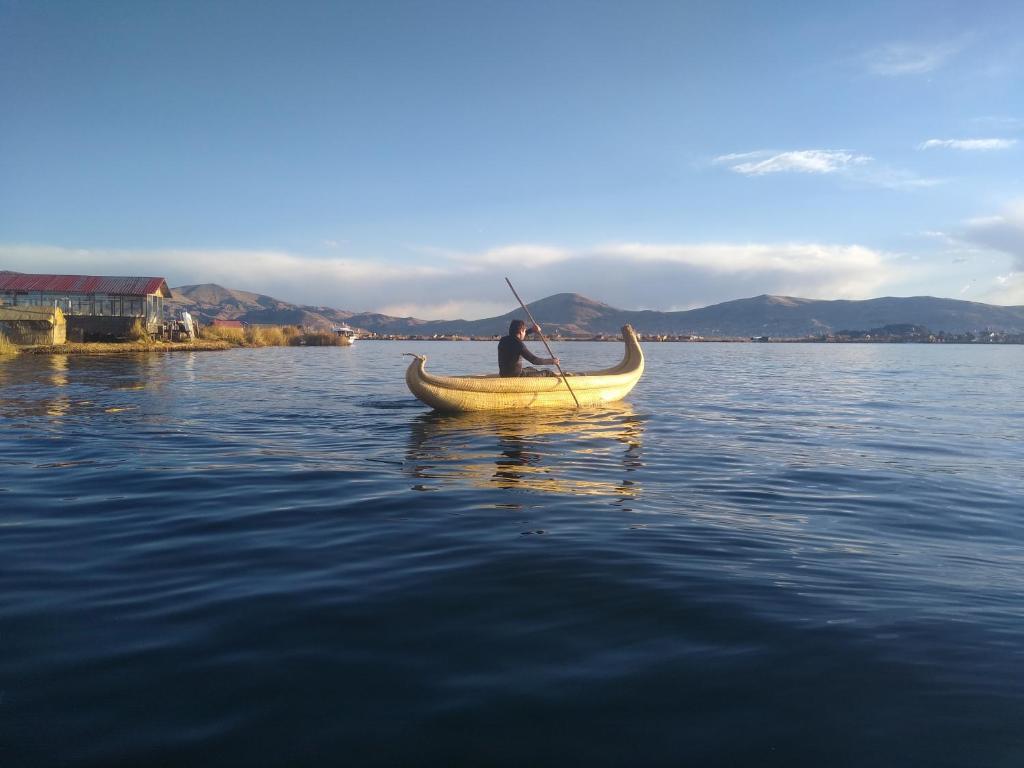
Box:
[169,284,1024,338]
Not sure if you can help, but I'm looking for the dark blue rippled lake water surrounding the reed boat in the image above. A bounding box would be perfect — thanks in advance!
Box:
[0,342,1024,768]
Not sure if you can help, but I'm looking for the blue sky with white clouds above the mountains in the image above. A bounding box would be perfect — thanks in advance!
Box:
[0,0,1024,319]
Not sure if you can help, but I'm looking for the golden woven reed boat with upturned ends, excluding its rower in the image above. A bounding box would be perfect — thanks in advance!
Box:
[406,326,643,412]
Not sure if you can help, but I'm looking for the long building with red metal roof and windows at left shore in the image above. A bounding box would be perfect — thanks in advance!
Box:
[0,272,171,341]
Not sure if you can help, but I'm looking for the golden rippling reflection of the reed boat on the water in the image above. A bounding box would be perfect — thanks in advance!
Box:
[406,402,644,503]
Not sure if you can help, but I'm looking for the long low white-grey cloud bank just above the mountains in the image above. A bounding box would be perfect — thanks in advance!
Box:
[0,243,900,319]
